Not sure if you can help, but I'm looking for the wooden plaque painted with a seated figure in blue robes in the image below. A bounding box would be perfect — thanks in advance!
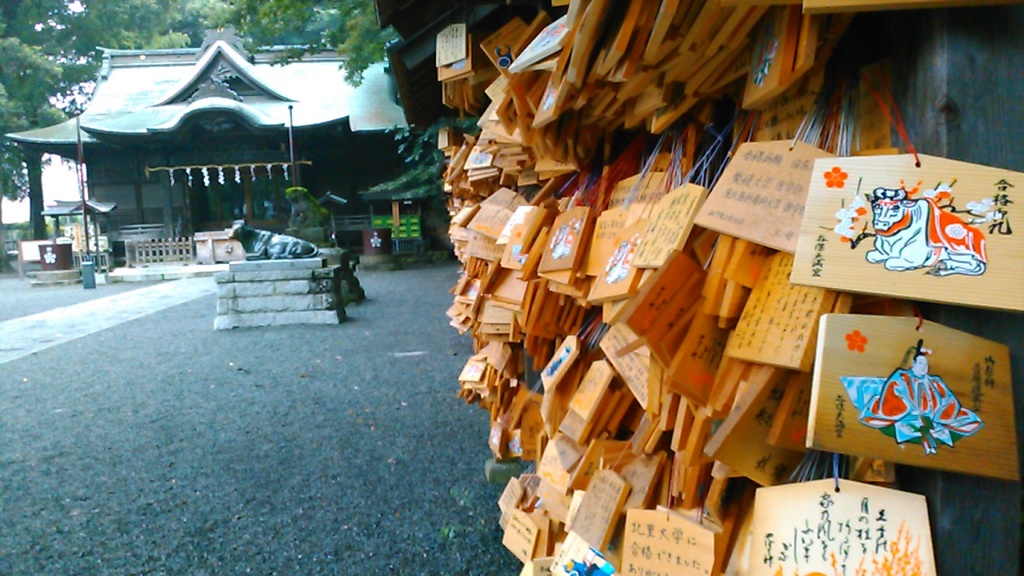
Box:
[807,314,1020,481]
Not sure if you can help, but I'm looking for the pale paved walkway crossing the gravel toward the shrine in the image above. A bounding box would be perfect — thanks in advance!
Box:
[0,277,217,365]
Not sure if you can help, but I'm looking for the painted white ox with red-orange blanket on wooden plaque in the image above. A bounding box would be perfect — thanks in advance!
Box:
[864,188,988,276]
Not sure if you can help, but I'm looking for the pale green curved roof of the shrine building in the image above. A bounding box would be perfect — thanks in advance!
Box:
[7,41,406,147]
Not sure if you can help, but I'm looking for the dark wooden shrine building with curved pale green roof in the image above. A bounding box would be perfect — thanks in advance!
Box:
[7,33,406,241]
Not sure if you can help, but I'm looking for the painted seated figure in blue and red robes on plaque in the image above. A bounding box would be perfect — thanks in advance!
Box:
[841,340,984,454]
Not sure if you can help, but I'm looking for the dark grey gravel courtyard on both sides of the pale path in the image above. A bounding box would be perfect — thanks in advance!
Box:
[0,264,512,575]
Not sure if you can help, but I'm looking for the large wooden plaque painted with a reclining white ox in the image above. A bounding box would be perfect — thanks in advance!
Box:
[792,155,1024,311]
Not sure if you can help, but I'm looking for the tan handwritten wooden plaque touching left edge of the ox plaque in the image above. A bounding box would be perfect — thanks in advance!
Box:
[696,140,833,253]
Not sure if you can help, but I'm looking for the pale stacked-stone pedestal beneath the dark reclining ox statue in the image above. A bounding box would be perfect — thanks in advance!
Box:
[213,258,345,330]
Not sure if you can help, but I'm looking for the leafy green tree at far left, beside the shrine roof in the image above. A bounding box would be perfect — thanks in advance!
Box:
[0,0,211,249]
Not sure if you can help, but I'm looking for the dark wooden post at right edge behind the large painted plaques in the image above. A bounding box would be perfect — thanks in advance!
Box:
[887,5,1024,576]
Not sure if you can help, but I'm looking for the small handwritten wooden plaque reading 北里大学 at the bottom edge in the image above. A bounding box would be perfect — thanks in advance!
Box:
[622,508,715,576]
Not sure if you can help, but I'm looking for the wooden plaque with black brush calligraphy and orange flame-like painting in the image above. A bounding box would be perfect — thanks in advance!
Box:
[746,479,935,576]
